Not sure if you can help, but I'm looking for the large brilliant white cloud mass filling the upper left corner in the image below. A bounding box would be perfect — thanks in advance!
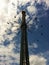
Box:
[0,0,19,42]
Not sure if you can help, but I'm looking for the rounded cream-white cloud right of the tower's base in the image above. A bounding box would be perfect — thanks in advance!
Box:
[30,55,47,65]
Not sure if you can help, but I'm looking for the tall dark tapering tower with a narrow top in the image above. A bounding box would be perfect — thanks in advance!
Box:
[20,11,29,65]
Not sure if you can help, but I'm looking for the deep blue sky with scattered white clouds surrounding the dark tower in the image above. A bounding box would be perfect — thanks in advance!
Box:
[0,0,49,65]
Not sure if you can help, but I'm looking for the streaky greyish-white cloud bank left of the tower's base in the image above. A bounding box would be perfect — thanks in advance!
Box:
[0,42,20,65]
